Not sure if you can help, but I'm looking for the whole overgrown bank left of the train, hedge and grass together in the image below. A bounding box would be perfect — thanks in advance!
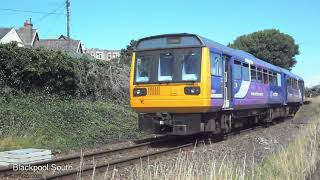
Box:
[0,43,139,151]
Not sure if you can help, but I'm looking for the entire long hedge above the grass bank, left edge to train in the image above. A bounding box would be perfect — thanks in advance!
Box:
[0,43,129,103]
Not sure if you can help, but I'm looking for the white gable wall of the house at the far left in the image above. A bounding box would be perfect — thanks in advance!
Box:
[0,28,24,47]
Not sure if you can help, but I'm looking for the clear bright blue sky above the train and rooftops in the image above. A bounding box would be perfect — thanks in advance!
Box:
[0,0,320,87]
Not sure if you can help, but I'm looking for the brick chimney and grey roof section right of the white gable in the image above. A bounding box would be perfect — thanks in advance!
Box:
[16,18,39,47]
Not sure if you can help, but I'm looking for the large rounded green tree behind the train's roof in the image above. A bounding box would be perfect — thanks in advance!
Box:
[228,29,299,70]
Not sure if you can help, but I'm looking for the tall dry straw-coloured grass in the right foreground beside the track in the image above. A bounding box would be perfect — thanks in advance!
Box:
[98,99,320,180]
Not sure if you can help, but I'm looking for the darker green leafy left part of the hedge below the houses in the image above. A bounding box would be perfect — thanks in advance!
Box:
[0,43,79,95]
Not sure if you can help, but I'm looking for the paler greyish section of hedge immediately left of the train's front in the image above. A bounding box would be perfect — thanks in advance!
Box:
[78,57,130,103]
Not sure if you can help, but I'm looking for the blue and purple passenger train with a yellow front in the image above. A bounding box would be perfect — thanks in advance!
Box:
[130,33,304,135]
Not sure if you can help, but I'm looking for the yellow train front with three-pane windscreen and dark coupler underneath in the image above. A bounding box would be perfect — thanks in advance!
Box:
[130,34,211,135]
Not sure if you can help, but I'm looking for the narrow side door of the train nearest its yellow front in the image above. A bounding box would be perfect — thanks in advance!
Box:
[223,55,232,109]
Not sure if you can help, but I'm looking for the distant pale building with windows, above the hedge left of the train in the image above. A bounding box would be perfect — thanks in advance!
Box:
[85,48,120,61]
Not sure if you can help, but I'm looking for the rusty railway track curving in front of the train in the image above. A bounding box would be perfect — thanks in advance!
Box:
[0,126,261,179]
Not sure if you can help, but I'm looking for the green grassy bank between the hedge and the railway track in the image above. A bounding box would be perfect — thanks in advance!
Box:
[0,95,141,151]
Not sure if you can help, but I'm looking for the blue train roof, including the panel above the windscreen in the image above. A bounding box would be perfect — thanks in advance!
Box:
[135,33,302,80]
